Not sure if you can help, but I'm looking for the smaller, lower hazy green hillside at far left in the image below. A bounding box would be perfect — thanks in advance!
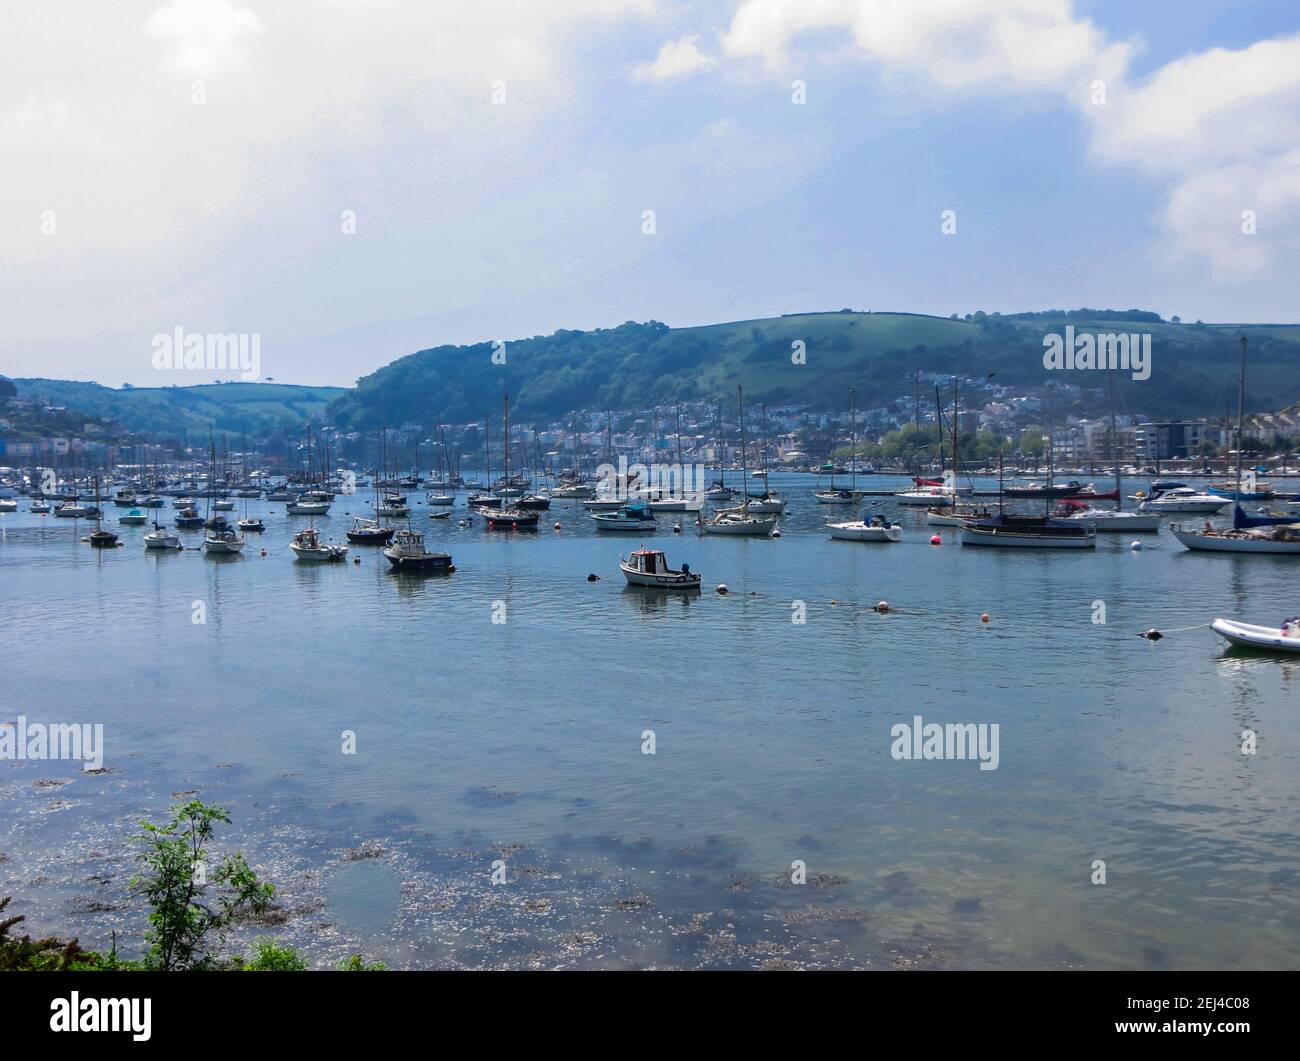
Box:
[13,378,345,437]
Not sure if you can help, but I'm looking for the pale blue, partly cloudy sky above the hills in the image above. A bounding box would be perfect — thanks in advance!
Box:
[0,0,1300,386]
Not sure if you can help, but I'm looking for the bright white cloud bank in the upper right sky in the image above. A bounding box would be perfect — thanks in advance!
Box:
[722,0,1300,280]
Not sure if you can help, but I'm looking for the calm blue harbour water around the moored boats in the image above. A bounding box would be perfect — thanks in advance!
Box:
[0,476,1300,967]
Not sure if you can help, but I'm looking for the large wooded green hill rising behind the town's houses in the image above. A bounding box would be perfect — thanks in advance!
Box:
[330,309,1300,429]
